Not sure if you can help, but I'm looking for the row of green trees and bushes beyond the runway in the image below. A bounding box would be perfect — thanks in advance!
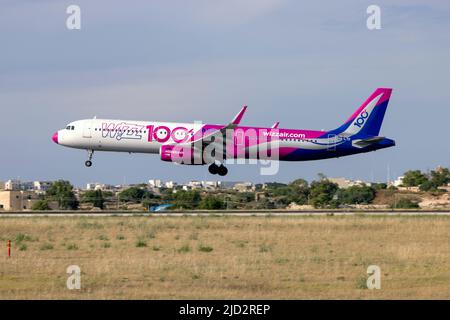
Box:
[29,168,450,210]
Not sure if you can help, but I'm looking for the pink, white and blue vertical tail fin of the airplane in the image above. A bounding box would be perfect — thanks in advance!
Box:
[331,88,392,136]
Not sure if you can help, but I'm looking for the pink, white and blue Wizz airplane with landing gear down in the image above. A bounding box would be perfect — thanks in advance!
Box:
[52,88,395,176]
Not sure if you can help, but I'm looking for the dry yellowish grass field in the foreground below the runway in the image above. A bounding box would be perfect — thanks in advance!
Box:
[0,216,450,299]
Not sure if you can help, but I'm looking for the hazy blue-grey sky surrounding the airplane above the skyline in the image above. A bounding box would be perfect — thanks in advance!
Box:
[0,0,450,186]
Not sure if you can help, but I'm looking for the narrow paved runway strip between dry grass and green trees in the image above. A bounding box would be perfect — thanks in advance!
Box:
[0,211,450,218]
